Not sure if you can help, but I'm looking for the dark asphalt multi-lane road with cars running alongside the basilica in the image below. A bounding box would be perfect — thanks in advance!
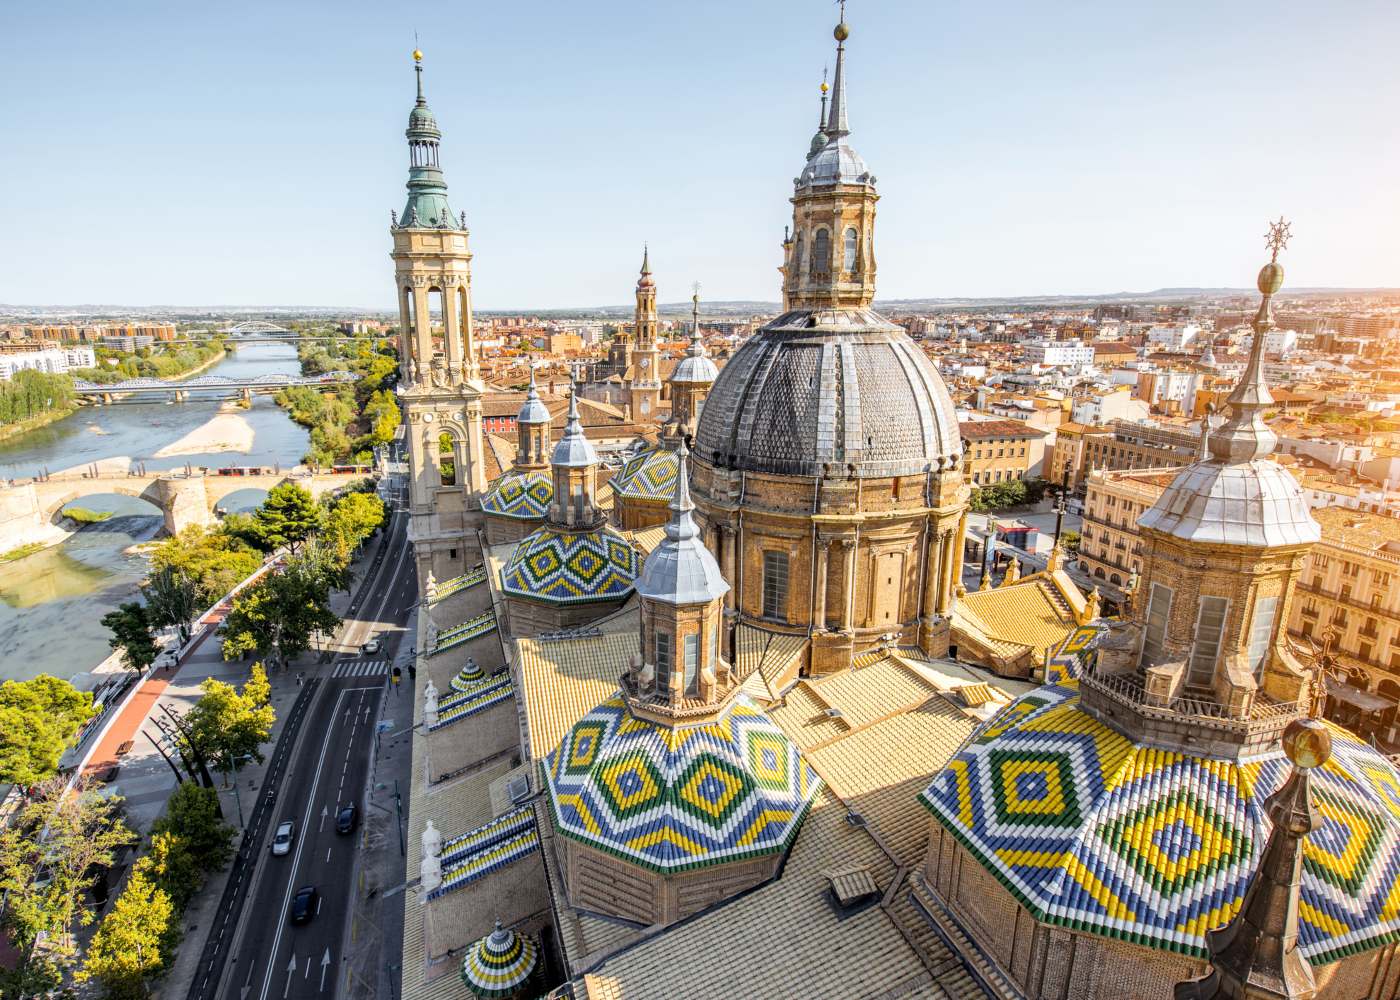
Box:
[189,501,417,1000]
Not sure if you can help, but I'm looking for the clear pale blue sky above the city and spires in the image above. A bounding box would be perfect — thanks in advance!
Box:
[0,0,1400,310]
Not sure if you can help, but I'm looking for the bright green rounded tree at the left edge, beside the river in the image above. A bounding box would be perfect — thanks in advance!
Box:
[0,674,94,786]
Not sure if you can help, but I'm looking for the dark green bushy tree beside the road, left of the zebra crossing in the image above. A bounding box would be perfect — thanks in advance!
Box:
[223,559,340,665]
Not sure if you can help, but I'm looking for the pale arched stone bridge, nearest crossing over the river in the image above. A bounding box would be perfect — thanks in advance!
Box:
[0,469,365,552]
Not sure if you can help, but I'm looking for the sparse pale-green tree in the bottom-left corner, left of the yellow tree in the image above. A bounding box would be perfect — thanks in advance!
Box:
[0,779,134,997]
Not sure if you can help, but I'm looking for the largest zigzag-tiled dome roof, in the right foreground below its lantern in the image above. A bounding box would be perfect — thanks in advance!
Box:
[920,681,1400,965]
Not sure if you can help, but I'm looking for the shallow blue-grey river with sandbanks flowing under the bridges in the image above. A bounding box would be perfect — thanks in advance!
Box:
[0,345,308,681]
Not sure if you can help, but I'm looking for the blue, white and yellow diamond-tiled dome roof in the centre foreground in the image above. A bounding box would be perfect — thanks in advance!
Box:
[540,695,822,873]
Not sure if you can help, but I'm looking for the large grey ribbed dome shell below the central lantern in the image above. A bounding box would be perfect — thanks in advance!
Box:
[694,308,962,478]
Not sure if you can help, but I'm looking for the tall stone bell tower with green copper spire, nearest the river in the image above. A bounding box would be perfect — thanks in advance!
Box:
[389,50,486,585]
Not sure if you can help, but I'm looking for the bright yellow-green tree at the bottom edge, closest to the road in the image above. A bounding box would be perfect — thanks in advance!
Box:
[78,859,179,1000]
